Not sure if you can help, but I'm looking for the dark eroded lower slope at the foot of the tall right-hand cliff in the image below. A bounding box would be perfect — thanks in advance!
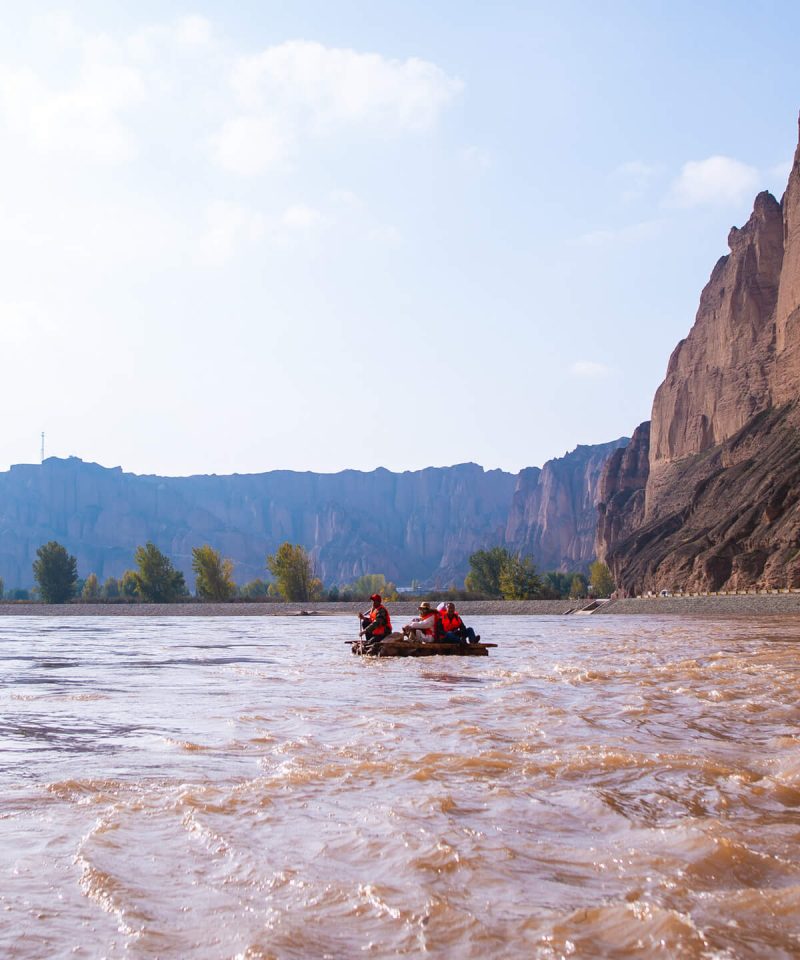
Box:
[600,404,800,594]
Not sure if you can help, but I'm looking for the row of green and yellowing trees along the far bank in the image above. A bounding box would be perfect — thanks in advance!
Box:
[7,540,614,603]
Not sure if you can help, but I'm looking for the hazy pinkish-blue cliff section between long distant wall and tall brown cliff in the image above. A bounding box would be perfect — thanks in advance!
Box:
[505,437,628,571]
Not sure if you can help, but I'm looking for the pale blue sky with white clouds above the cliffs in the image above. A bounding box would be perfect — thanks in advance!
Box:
[0,0,800,475]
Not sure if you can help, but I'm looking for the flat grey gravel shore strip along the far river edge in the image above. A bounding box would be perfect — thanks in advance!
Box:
[0,593,800,624]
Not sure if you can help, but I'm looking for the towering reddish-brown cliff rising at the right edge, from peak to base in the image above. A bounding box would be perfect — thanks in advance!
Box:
[598,112,800,594]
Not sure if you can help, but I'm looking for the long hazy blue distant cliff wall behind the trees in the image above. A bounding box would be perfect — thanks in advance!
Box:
[0,445,624,587]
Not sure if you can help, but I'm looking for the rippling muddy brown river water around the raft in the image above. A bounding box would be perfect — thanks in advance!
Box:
[0,615,800,960]
